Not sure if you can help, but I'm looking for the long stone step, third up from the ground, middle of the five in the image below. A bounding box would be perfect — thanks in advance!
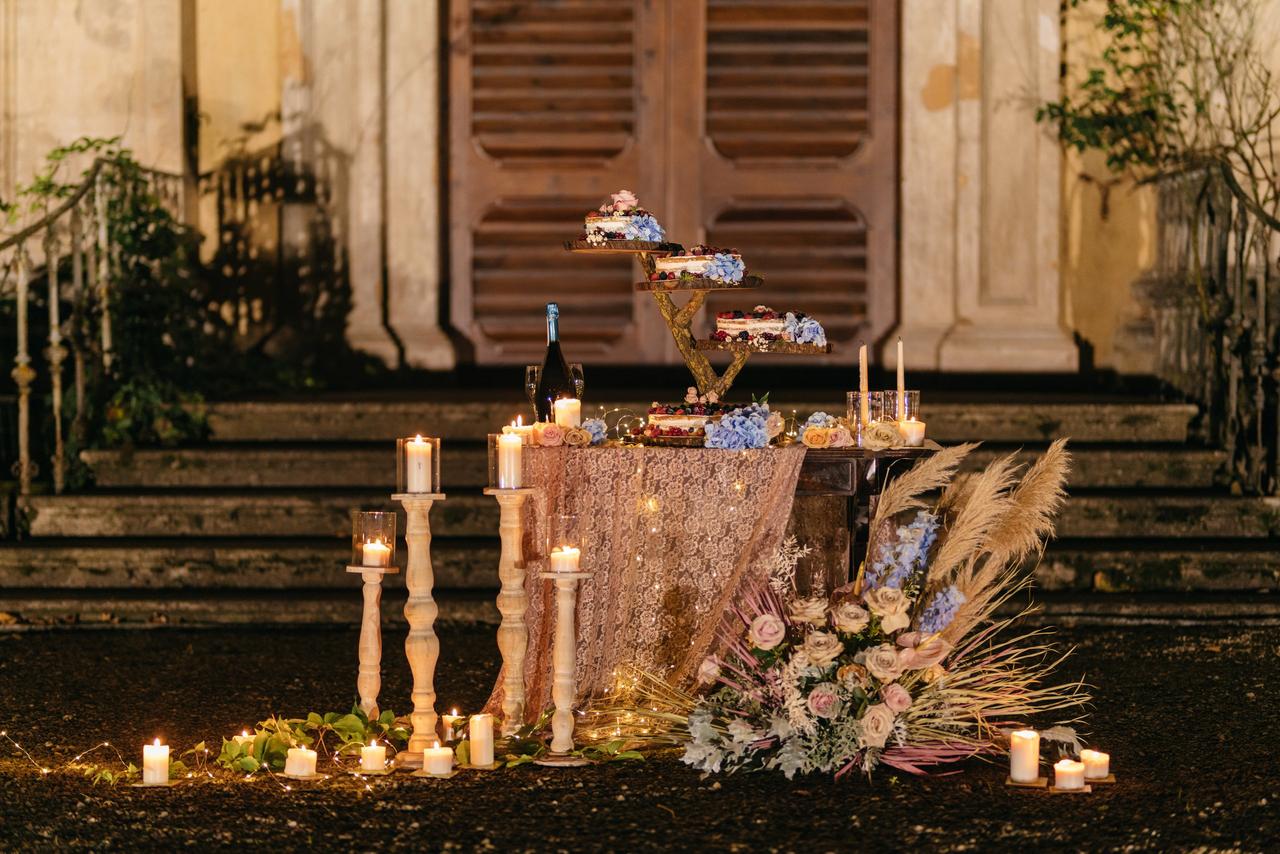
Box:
[19,492,1280,539]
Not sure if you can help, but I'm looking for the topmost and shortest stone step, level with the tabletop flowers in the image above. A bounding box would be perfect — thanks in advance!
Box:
[209,396,1197,442]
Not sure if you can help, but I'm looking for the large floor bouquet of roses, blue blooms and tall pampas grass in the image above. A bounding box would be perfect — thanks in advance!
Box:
[593,440,1088,777]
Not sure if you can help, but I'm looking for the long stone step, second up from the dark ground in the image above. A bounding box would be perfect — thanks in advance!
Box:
[0,539,1280,597]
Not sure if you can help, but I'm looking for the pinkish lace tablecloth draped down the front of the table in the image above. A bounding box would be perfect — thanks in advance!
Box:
[486,446,805,720]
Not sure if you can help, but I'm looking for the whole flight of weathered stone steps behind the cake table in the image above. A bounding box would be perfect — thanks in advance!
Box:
[0,401,1280,625]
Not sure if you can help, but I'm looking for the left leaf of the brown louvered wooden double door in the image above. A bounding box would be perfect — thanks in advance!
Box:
[449,0,660,364]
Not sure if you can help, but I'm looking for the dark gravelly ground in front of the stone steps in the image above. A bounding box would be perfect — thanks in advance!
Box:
[0,625,1280,851]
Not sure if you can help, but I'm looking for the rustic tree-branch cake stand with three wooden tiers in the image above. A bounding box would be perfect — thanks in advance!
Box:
[564,241,831,398]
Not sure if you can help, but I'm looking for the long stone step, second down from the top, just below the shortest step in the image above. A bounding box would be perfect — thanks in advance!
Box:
[81,444,1225,493]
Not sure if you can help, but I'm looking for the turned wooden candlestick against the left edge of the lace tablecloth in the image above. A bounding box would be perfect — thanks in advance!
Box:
[484,488,534,735]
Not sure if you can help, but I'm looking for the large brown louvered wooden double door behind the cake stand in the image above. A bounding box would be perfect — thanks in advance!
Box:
[449,0,897,366]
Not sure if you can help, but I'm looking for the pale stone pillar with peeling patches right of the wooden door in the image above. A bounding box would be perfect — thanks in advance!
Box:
[884,0,1078,371]
